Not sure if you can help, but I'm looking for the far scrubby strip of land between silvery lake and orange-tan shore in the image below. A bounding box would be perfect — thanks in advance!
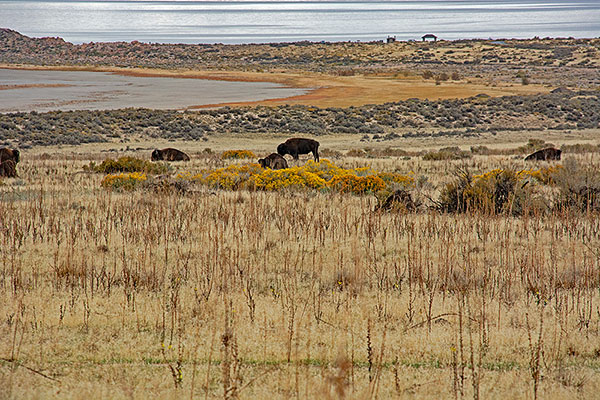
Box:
[0,29,600,88]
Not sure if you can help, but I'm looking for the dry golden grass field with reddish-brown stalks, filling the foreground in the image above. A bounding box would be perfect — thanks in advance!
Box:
[0,132,600,399]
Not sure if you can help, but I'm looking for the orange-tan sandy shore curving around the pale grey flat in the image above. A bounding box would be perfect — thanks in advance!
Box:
[0,64,552,109]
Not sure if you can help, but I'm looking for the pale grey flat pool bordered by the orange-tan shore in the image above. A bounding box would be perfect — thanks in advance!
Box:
[0,69,306,113]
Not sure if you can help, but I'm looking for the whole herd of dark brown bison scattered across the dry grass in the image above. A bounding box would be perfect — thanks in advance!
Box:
[0,138,561,178]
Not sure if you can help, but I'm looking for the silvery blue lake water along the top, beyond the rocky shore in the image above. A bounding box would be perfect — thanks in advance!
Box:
[0,0,600,44]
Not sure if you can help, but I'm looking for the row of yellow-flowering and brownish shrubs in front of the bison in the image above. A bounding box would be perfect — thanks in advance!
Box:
[101,159,600,216]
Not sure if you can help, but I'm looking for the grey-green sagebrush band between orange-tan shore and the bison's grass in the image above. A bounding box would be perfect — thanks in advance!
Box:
[0,89,600,147]
